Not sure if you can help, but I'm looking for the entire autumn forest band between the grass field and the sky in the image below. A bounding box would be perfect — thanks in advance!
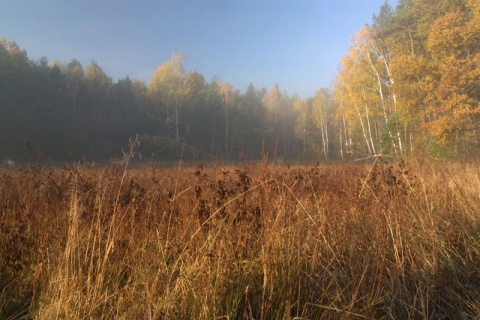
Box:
[0,0,480,163]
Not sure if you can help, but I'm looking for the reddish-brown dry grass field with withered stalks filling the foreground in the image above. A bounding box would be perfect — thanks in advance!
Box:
[0,159,480,320]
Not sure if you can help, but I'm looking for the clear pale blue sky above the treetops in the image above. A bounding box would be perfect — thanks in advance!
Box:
[0,0,397,98]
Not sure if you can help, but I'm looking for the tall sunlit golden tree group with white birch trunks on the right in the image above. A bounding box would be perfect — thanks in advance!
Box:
[333,0,480,158]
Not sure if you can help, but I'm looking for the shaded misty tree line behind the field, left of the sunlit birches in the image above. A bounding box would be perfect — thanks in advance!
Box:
[0,39,330,162]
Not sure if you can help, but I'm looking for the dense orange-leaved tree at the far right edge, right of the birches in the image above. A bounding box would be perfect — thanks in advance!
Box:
[427,2,480,152]
